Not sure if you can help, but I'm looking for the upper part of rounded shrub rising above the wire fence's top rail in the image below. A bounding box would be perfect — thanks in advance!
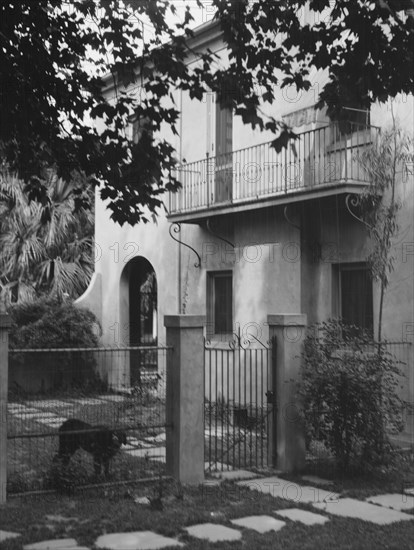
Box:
[9,298,100,349]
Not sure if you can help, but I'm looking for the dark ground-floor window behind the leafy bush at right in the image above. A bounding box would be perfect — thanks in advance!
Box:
[338,263,374,335]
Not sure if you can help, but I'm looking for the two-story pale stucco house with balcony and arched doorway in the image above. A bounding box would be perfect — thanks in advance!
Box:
[79,18,414,444]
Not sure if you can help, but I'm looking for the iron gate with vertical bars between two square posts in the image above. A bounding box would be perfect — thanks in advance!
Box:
[204,335,276,471]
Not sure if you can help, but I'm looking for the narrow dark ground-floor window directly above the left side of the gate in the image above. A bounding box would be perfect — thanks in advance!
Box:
[207,271,233,336]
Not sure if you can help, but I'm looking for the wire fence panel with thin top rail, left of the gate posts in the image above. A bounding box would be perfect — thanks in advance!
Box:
[7,346,171,494]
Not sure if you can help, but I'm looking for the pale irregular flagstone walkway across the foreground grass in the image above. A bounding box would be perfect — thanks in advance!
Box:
[0,471,414,550]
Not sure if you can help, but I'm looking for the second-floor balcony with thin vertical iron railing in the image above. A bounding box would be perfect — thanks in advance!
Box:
[169,123,378,222]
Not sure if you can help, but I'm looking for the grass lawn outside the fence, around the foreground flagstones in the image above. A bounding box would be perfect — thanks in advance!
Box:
[0,474,414,550]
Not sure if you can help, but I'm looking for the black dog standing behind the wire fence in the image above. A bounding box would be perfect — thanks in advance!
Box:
[53,418,127,476]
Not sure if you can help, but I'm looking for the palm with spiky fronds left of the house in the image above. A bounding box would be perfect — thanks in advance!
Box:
[0,171,93,303]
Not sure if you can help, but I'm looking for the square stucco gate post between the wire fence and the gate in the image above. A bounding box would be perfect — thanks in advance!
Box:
[164,315,206,484]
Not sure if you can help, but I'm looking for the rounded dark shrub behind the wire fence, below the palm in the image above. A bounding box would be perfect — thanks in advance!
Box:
[9,299,104,394]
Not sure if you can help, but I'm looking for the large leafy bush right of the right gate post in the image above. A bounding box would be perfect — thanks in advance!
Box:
[299,320,401,471]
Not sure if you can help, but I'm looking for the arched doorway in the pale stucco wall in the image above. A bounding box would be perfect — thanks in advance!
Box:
[120,256,158,386]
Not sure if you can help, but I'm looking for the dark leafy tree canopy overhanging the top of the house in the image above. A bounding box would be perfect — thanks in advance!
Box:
[0,0,414,224]
